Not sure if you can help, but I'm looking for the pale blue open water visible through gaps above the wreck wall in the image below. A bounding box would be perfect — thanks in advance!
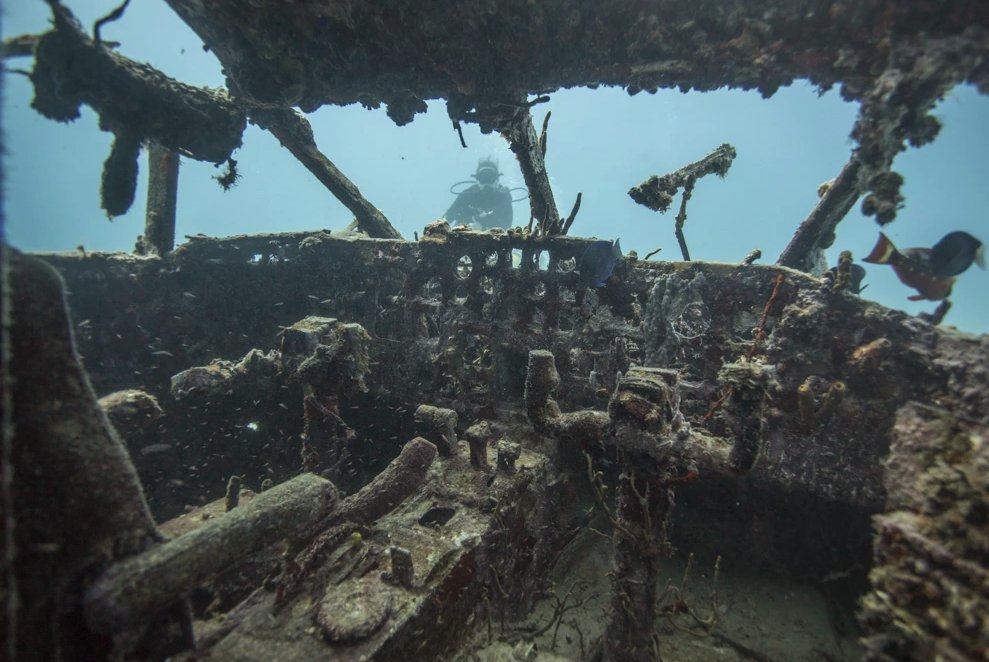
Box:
[3,0,989,332]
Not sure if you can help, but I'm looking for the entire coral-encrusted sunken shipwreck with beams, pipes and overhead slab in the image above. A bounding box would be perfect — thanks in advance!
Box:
[0,0,989,660]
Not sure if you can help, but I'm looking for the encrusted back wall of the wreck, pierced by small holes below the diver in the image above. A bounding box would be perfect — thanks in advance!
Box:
[30,230,980,528]
